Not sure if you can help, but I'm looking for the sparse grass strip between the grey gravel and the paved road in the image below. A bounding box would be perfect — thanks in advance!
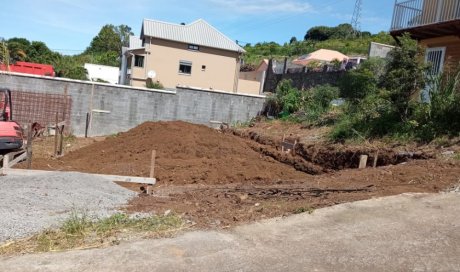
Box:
[0,212,184,255]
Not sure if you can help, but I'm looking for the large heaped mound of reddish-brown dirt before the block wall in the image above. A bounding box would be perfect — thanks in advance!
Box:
[33,121,309,184]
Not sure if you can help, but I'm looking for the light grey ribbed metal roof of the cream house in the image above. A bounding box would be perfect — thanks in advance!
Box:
[142,19,246,52]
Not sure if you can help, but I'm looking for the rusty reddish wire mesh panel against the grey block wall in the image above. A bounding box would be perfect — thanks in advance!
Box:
[11,91,72,133]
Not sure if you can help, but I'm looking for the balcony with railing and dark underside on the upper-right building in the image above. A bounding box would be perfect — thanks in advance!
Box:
[390,0,460,39]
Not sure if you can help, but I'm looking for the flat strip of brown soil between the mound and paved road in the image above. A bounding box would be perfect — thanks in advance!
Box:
[127,160,460,228]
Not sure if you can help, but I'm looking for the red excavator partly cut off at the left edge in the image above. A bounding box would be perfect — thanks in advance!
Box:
[0,88,23,154]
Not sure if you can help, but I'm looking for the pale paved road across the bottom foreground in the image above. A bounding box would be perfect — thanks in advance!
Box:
[0,193,460,272]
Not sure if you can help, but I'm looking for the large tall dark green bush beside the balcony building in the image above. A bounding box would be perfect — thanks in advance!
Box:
[330,35,434,141]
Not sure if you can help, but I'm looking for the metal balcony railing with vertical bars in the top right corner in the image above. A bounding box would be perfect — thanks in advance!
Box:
[391,0,460,31]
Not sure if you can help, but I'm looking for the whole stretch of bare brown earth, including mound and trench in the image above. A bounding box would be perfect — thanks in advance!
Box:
[20,121,460,228]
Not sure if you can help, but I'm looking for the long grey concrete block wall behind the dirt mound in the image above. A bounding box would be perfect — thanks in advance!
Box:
[0,73,265,136]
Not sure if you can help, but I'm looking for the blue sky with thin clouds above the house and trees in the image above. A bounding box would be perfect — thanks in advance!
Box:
[0,0,394,54]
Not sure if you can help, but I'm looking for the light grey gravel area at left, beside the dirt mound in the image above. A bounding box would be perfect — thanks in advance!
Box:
[0,173,136,243]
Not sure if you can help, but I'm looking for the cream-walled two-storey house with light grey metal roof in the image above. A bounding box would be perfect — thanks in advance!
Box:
[120,19,259,94]
